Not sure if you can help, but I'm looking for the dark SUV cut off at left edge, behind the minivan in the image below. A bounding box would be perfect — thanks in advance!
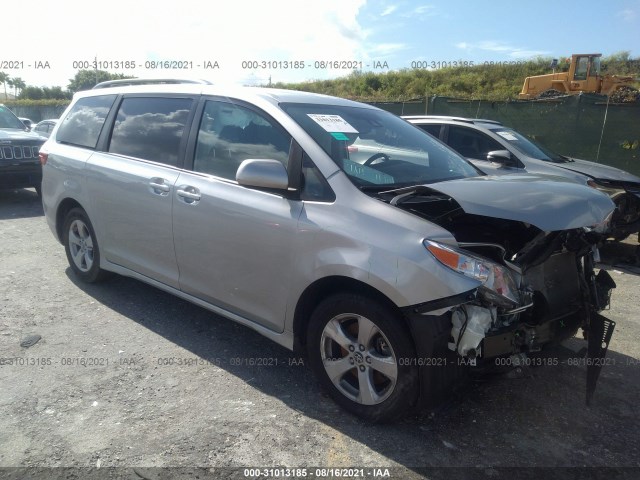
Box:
[0,105,46,195]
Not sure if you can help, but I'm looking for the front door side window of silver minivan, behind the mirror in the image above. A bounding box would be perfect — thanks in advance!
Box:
[193,101,291,180]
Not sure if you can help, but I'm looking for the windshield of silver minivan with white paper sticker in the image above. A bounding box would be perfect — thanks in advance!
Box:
[280,103,480,189]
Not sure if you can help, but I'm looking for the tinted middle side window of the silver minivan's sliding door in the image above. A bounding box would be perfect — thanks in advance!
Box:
[109,97,193,165]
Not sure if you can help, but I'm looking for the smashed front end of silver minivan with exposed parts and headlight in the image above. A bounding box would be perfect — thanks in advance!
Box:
[381,180,615,404]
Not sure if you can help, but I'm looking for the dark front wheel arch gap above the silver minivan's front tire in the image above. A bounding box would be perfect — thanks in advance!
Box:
[293,275,415,352]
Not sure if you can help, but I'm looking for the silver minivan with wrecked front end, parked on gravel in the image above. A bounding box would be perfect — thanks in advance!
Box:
[41,81,615,421]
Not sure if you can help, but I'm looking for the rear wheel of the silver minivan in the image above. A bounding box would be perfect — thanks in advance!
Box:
[62,208,106,283]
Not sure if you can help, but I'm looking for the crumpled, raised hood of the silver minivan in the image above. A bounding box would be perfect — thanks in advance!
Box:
[428,175,615,232]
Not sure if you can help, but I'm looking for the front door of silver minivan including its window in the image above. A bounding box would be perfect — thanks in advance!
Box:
[173,100,302,332]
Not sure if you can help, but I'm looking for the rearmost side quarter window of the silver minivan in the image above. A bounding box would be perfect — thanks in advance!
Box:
[56,95,116,148]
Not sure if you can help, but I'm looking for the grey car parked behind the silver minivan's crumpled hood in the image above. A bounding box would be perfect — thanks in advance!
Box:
[403,115,640,240]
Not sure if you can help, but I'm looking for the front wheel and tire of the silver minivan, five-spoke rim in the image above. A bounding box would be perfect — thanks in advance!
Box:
[307,294,419,422]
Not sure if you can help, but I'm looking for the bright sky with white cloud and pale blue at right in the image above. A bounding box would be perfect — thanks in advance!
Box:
[0,0,640,89]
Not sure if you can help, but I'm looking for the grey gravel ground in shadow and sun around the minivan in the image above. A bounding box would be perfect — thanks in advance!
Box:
[0,190,640,480]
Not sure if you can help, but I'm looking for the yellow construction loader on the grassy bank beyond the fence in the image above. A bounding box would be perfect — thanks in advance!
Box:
[519,53,638,102]
